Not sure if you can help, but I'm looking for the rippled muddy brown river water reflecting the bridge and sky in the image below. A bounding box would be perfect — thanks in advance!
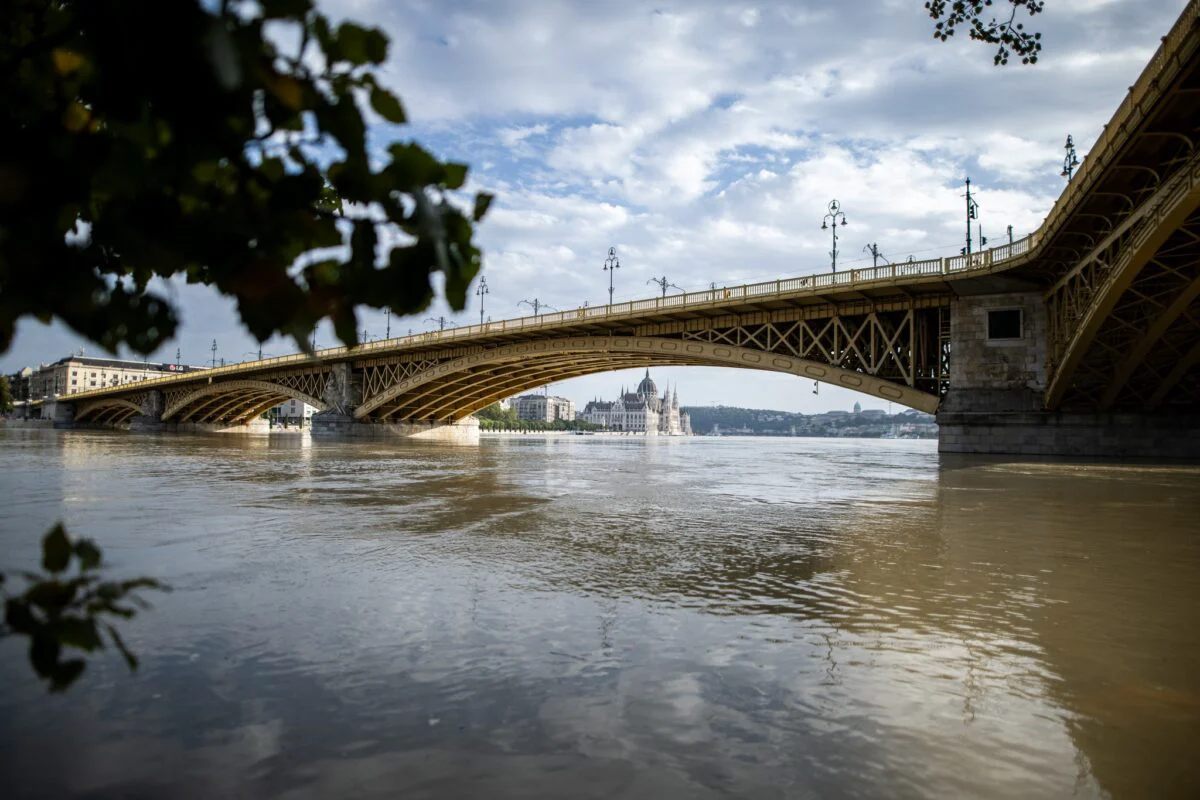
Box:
[0,431,1200,798]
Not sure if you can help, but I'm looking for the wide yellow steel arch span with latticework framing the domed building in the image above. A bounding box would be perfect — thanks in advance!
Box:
[354,299,948,422]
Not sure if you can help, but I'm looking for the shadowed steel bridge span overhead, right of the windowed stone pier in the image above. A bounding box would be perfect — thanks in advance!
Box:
[1041,28,1200,413]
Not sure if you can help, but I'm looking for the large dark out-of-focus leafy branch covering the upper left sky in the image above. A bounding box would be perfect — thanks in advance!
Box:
[0,0,491,353]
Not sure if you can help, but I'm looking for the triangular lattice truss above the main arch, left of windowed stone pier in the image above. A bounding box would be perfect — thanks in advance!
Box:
[683,308,949,395]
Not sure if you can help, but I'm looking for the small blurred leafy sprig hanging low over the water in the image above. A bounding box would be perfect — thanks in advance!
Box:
[0,524,167,692]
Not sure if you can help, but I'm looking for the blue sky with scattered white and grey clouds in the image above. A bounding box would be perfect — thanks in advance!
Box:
[0,0,1186,413]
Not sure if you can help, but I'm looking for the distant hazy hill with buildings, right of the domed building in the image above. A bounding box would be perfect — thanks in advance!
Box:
[683,405,937,439]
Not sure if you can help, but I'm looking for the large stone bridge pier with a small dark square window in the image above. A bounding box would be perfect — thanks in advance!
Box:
[937,289,1200,459]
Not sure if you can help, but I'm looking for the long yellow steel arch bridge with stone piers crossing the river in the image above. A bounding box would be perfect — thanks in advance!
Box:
[37,0,1200,456]
